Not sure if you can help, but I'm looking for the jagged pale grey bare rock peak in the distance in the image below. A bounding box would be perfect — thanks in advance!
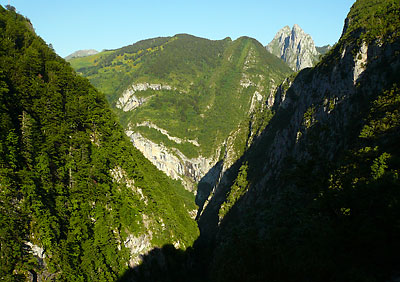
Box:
[266,24,320,71]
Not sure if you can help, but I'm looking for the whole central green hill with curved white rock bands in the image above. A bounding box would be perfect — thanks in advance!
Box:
[70,34,291,189]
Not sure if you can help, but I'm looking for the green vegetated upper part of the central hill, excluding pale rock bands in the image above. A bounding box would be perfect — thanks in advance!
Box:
[70,34,291,164]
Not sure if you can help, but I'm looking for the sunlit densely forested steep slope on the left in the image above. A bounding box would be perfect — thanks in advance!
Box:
[0,6,198,281]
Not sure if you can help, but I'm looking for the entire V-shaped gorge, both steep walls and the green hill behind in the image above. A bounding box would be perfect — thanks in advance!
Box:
[0,0,400,282]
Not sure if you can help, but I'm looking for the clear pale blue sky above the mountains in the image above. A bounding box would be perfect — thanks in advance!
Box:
[4,0,354,57]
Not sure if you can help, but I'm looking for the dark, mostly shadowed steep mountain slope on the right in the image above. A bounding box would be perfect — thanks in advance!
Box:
[199,0,400,281]
